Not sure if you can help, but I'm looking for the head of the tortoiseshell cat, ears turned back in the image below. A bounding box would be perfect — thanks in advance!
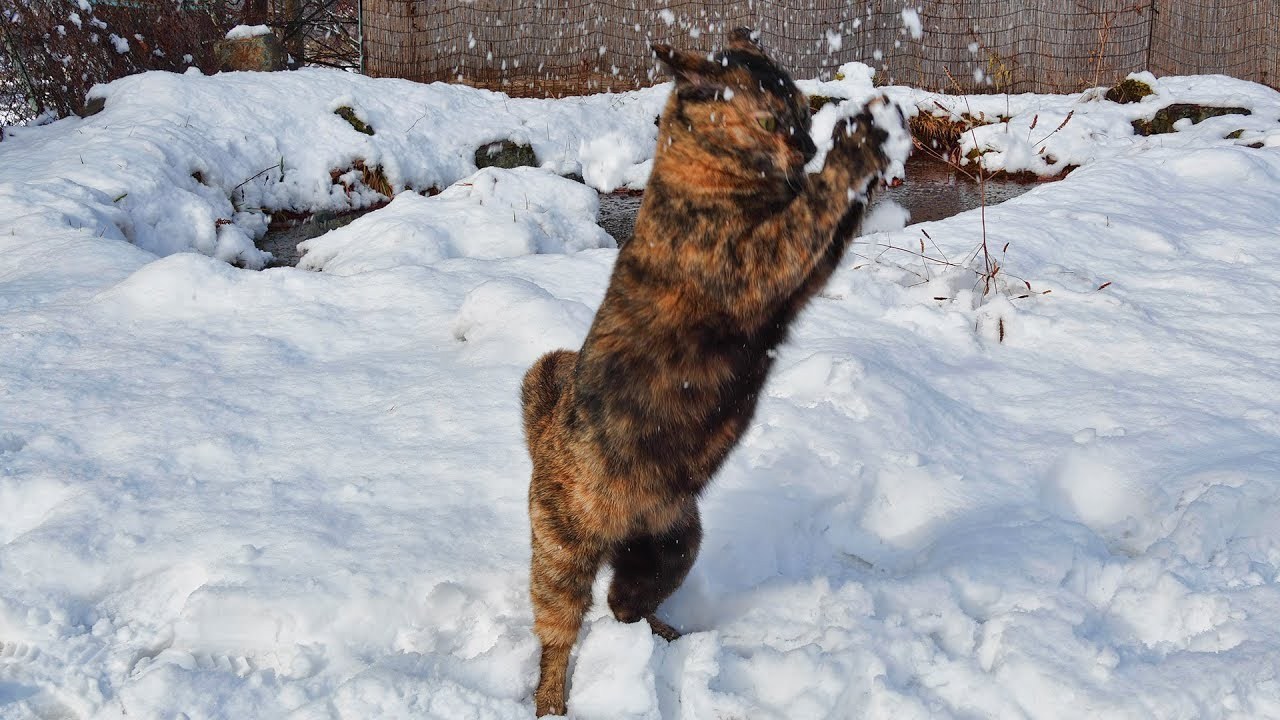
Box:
[653,28,817,188]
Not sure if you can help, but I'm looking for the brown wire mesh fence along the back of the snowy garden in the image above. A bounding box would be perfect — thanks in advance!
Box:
[362,0,1280,96]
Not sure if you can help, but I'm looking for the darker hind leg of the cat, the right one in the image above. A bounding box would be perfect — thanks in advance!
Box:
[609,500,703,641]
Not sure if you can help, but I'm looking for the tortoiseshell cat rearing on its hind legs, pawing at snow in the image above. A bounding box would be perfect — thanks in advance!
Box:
[521,29,901,716]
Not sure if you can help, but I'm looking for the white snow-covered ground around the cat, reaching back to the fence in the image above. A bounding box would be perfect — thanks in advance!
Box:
[0,68,1280,720]
